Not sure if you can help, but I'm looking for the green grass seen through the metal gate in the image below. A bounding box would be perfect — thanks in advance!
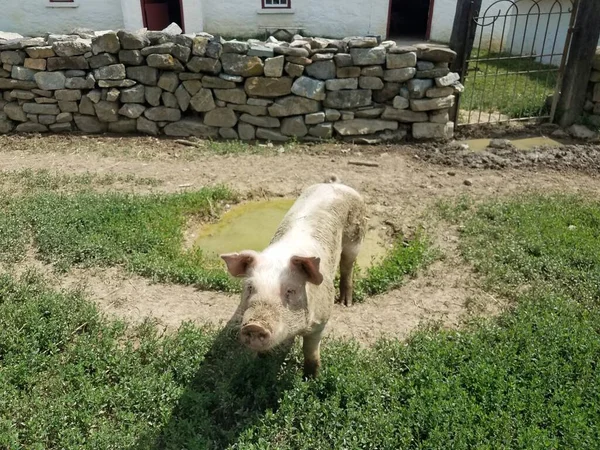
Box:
[461,51,558,122]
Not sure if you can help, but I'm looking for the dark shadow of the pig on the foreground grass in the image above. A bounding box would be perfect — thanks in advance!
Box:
[134,313,299,450]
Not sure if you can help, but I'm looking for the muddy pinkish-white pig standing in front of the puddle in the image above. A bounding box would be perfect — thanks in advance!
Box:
[221,175,367,378]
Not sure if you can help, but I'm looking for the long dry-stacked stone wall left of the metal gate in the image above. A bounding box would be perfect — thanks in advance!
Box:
[0,31,462,142]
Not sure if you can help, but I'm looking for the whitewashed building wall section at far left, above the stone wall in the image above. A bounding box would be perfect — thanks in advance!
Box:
[0,0,124,36]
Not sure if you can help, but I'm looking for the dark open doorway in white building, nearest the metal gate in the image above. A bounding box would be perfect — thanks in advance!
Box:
[388,0,431,40]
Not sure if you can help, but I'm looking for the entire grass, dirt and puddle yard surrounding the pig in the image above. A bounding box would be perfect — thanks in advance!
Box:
[0,135,600,449]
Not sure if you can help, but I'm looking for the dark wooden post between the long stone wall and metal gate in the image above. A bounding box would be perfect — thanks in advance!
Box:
[450,0,482,121]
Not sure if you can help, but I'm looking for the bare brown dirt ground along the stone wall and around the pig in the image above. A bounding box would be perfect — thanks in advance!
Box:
[0,135,600,345]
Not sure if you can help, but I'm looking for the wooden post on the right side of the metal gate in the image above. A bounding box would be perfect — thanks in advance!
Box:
[556,0,600,127]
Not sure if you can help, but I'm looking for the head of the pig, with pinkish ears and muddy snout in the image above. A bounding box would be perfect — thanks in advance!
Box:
[221,250,323,352]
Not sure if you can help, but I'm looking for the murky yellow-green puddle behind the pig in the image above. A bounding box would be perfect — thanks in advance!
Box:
[194,199,387,268]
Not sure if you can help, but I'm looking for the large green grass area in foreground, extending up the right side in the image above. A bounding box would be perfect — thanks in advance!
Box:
[0,197,600,449]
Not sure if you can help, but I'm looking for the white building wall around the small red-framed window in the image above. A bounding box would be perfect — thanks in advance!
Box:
[204,0,389,38]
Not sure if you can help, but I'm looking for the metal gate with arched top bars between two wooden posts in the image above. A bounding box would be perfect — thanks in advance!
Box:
[455,0,578,125]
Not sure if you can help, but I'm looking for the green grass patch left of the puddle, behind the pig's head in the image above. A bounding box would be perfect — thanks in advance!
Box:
[0,187,238,291]
